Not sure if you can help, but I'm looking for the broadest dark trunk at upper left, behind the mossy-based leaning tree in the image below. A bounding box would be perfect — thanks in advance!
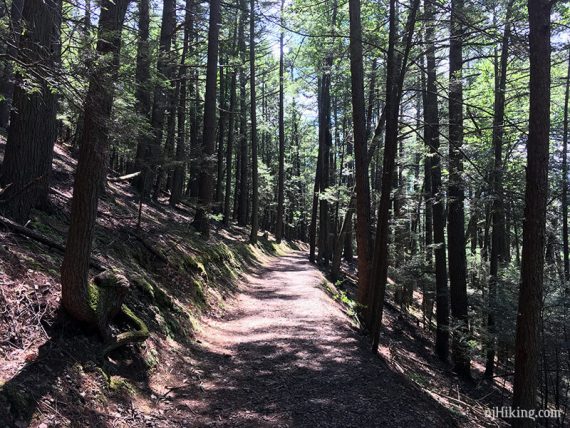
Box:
[0,0,61,222]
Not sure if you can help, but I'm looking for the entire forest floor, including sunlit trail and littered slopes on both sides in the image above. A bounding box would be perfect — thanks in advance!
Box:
[0,140,510,428]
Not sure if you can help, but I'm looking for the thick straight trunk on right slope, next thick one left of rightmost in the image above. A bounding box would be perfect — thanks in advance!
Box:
[447,0,471,378]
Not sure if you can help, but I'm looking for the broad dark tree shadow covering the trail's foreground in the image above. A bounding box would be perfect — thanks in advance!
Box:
[164,318,456,427]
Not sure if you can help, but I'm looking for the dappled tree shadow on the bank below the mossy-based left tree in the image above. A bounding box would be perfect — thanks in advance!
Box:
[0,311,149,427]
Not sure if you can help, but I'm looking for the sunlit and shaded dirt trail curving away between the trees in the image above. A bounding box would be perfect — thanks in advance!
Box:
[161,252,452,427]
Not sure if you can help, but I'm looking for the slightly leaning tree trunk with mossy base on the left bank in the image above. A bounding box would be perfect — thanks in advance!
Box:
[61,0,130,328]
